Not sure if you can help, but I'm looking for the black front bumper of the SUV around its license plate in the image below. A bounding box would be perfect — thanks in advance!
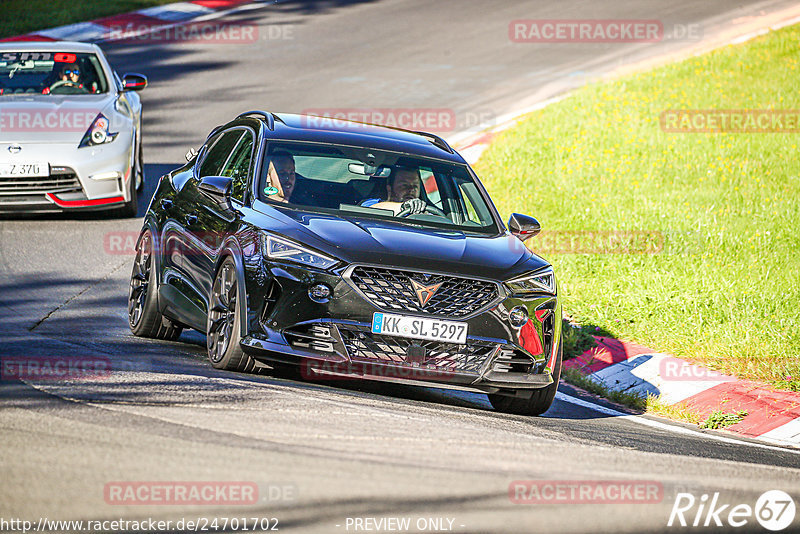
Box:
[242,264,561,393]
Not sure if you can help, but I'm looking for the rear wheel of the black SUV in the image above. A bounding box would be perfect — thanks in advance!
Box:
[128,230,183,341]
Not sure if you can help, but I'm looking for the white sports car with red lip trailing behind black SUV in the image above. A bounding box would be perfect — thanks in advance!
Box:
[0,42,147,217]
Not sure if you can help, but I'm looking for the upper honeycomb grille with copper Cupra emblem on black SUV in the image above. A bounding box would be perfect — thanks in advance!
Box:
[350,266,498,317]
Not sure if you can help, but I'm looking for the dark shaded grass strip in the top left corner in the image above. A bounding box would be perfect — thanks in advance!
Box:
[0,0,184,39]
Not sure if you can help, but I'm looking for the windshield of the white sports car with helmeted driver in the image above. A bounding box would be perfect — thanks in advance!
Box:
[0,51,108,96]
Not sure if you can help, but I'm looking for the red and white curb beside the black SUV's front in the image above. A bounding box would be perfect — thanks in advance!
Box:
[564,336,800,447]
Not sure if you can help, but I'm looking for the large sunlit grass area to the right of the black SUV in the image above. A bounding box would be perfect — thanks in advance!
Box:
[476,26,800,391]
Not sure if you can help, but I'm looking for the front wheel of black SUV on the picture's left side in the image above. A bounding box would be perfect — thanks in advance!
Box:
[206,256,256,373]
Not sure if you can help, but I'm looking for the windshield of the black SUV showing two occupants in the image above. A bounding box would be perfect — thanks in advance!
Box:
[258,142,498,233]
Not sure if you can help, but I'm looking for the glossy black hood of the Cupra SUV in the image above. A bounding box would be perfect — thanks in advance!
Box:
[253,208,548,280]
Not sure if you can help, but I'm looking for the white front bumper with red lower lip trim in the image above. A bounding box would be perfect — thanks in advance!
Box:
[0,138,133,212]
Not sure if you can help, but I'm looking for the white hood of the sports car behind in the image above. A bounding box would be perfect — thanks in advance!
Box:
[0,94,114,146]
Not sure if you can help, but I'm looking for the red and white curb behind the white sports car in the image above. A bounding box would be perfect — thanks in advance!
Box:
[0,0,253,42]
